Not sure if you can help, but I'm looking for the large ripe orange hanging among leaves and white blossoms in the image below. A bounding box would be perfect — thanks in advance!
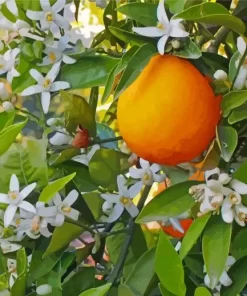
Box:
[117,55,220,165]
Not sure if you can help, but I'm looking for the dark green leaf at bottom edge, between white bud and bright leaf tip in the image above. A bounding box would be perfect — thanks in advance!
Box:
[62,267,95,296]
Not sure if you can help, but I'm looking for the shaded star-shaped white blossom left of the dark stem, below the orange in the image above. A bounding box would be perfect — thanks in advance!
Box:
[101,175,139,223]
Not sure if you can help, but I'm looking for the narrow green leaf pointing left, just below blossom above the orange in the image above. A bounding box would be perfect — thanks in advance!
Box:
[109,26,157,46]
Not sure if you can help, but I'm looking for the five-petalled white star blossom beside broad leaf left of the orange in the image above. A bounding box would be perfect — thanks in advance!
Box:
[21,62,70,113]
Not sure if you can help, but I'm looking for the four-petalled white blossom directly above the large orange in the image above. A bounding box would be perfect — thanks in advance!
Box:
[133,0,189,55]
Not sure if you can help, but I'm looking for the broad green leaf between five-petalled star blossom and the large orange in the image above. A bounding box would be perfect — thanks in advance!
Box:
[61,55,119,89]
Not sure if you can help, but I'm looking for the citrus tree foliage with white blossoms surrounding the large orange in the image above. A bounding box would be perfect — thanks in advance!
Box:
[0,0,247,296]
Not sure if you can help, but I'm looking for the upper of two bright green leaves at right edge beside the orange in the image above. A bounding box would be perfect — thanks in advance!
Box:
[221,90,247,117]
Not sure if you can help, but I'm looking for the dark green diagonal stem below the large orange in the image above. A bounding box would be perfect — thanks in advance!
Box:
[108,186,152,285]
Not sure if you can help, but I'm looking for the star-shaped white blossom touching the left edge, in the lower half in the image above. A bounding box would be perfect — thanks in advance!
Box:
[0,174,36,227]
